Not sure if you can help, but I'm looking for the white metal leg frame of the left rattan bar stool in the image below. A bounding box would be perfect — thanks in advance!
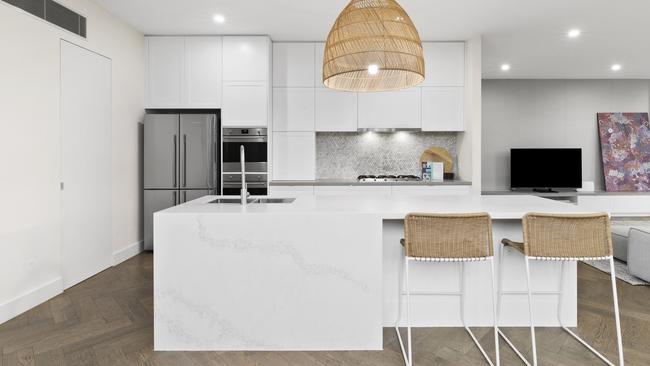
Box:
[395,255,500,366]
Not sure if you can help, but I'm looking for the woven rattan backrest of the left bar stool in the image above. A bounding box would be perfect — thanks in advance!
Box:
[404,213,494,259]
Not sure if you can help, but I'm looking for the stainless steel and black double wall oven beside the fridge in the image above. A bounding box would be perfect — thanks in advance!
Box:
[221,127,268,196]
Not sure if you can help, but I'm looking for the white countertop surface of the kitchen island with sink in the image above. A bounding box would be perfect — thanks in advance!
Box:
[156,195,585,220]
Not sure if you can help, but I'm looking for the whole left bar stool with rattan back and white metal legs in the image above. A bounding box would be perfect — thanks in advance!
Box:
[395,213,500,366]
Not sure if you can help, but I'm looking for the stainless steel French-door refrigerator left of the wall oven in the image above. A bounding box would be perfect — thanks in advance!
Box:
[143,114,219,250]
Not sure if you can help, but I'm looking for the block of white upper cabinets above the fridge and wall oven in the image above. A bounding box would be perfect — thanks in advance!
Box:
[145,36,271,127]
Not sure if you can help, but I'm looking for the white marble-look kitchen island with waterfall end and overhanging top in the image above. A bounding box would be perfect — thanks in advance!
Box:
[154,195,581,351]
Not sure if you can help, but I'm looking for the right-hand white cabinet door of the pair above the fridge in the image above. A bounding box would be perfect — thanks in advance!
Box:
[185,37,221,108]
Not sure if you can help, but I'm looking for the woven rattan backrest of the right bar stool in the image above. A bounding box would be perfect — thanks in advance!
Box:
[523,213,612,258]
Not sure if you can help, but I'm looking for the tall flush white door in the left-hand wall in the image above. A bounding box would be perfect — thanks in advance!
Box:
[61,40,113,288]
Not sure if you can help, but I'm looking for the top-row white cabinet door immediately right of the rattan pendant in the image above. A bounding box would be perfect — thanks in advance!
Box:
[421,42,465,86]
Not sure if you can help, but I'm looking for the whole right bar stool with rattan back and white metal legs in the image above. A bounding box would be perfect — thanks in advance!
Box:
[497,213,624,366]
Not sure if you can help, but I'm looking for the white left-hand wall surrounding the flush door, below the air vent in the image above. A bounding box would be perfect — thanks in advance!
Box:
[0,0,144,323]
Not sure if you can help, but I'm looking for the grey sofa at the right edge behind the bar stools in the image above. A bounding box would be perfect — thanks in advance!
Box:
[612,222,650,282]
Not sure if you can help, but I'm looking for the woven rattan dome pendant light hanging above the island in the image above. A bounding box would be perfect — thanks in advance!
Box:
[323,0,424,92]
